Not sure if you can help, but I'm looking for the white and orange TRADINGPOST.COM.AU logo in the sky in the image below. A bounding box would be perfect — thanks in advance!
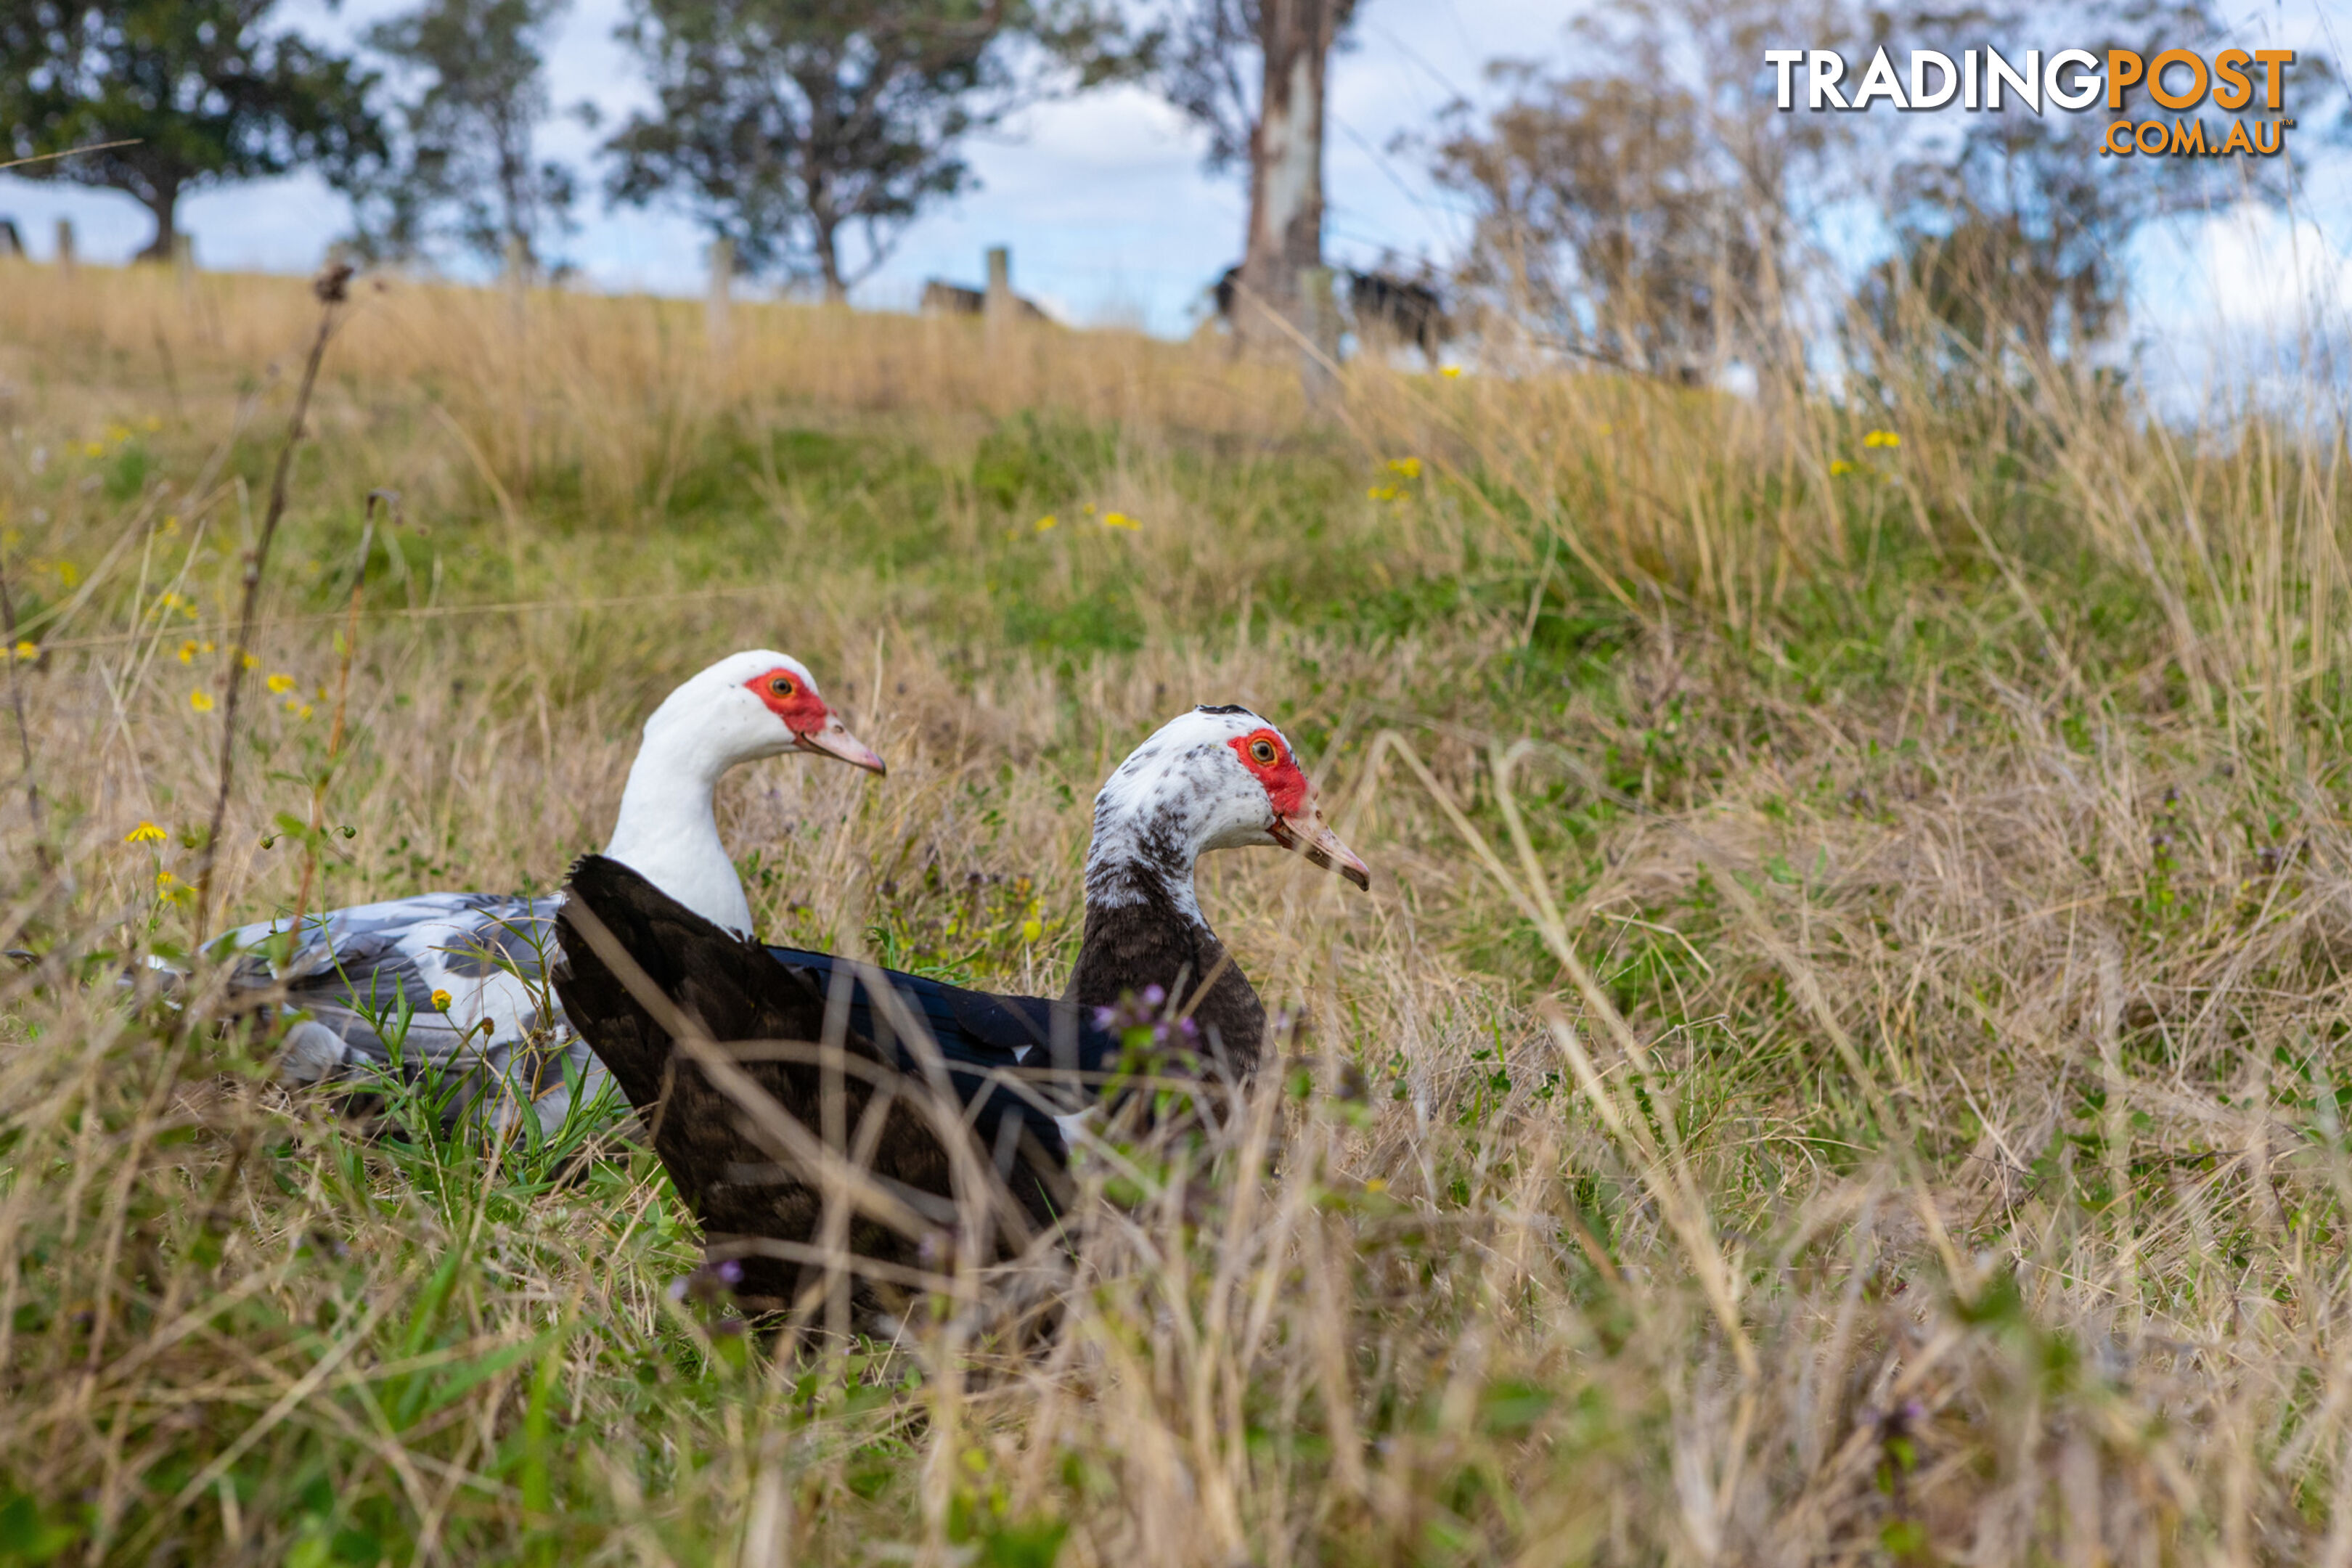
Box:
[1764,47,2295,158]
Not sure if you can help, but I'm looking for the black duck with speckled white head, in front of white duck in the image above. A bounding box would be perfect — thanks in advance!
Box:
[555,708,1371,1302]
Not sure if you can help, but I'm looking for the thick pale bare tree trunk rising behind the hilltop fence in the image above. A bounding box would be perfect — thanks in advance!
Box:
[1235,0,1350,346]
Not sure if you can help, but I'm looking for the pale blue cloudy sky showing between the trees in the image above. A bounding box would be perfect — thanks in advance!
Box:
[0,0,2352,369]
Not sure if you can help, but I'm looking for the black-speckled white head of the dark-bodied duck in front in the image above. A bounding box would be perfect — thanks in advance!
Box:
[1087,706,1371,910]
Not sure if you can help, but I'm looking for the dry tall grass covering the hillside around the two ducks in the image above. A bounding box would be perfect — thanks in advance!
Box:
[0,268,2352,1568]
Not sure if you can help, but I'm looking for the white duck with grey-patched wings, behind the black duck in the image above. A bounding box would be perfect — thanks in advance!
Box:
[216,649,884,1131]
